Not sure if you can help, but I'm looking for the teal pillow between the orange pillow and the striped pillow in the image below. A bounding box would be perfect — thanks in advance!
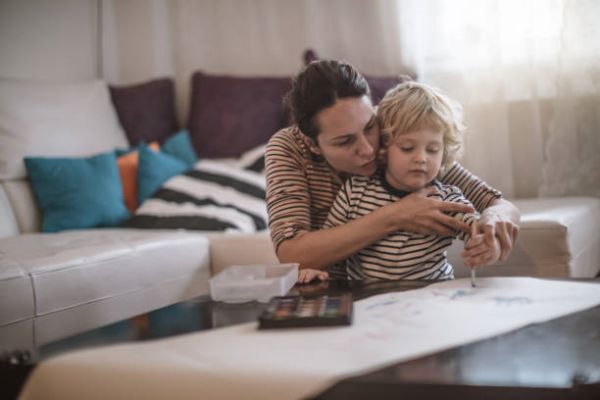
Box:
[137,143,190,204]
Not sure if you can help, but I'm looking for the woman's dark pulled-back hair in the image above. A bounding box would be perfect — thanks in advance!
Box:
[285,60,371,140]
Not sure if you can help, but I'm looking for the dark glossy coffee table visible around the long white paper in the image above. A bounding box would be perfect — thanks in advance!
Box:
[4,279,600,400]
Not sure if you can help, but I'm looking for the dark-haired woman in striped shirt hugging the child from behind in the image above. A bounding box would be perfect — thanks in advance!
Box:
[265,60,520,269]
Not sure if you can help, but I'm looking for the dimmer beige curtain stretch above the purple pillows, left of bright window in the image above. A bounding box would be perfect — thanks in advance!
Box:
[101,0,406,130]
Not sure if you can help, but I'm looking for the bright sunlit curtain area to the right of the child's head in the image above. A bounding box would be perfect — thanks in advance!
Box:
[397,0,600,197]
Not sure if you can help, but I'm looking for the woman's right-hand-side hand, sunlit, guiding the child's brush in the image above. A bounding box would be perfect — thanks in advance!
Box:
[461,199,521,261]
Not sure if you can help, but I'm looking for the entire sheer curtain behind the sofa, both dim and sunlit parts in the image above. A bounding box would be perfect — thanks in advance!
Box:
[102,0,600,197]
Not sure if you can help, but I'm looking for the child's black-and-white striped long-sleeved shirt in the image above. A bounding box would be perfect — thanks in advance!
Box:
[323,174,478,280]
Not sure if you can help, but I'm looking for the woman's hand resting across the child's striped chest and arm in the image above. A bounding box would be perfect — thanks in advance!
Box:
[384,187,475,236]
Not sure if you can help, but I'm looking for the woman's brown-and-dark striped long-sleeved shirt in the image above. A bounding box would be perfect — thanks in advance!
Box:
[265,126,502,253]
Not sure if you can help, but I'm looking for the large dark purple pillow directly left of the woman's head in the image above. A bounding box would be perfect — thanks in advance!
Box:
[188,72,291,158]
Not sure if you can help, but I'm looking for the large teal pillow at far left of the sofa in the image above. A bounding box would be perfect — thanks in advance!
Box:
[25,151,129,232]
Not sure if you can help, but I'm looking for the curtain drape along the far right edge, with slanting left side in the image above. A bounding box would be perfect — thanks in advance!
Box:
[540,0,600,197]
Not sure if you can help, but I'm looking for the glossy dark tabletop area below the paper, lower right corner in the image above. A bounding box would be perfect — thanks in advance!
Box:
[318,279,600,400]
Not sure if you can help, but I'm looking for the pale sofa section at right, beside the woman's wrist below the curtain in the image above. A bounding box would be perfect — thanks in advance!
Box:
[448,197,600,278]
